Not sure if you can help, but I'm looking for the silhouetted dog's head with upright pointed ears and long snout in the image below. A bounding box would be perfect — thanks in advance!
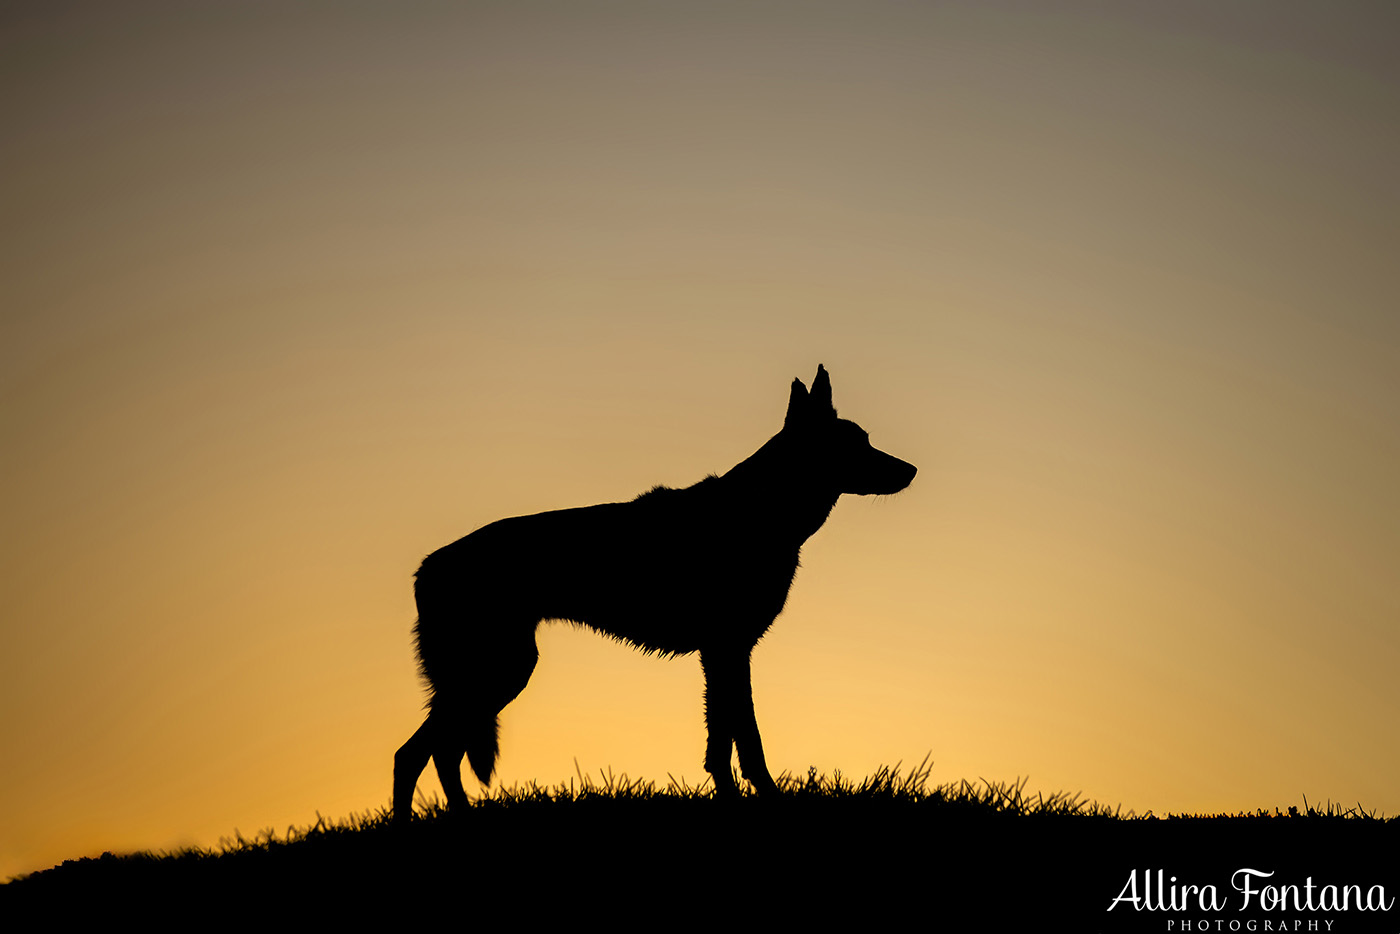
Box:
[783,365,918,496]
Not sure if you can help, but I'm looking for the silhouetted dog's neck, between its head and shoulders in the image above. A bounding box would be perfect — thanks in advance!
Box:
[720,433,841,546]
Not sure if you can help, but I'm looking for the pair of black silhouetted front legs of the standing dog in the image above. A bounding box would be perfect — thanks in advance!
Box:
[700,648,778,797]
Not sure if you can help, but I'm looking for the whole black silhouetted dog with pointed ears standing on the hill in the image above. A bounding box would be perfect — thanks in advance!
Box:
[393,365,917,821]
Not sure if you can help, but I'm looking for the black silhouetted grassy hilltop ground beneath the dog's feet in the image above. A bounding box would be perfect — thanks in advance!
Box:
[0,766,1400,931]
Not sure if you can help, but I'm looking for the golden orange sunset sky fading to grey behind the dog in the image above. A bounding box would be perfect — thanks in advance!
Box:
[0,1,1400,878]
